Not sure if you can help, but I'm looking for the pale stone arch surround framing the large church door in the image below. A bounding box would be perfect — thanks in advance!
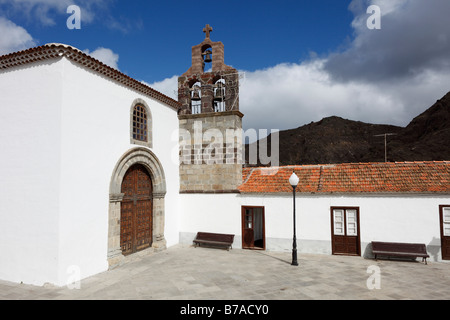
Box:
[108,148,166,267]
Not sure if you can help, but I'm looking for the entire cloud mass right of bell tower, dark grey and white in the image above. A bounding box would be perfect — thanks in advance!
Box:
[236,0,450,130]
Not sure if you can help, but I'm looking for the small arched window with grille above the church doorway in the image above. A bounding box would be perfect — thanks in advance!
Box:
[130,99,152,148]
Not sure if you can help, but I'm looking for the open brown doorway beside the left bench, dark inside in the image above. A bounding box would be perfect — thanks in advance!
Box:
[242,207,265,249]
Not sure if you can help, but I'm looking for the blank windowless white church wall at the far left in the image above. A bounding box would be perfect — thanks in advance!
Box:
[0,62,62,285]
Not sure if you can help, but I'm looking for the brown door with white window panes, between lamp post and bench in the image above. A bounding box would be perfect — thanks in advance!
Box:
[331,207,361,256]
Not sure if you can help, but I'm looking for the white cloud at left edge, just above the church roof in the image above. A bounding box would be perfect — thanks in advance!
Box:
[0,17,36,55]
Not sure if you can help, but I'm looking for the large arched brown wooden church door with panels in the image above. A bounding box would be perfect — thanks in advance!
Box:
[120,165,152,255]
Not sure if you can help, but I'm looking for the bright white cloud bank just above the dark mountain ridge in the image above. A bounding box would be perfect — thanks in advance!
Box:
[240,60,450,130]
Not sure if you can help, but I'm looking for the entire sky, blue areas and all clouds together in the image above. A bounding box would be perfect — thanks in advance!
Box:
[0,0,450,129]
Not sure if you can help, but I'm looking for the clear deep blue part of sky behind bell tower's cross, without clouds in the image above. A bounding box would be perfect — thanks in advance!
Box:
[2,0,352,82]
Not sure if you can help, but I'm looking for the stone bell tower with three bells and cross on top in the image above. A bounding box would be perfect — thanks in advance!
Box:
[178,25,243,193]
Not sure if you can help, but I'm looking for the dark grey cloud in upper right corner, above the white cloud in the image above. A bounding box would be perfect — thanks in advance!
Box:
[324,0,450,82]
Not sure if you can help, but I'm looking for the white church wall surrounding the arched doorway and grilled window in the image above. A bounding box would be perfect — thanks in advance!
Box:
[59,59,179,285]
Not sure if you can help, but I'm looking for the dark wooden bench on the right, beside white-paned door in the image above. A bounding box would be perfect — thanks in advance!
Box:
[372,241,430,264]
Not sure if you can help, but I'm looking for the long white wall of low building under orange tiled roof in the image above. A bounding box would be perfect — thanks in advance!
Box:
[180,194,450,261]
